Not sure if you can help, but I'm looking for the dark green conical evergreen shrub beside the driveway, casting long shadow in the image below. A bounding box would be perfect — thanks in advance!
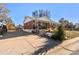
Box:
[51,25,65,41]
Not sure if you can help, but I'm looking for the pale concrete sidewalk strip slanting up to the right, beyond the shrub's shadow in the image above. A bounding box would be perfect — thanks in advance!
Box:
[46,37,79,55]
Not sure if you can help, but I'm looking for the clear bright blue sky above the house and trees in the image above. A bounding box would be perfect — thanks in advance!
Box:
[7,3,79,25]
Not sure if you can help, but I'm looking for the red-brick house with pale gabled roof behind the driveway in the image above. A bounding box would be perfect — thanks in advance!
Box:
[24,16,52,29]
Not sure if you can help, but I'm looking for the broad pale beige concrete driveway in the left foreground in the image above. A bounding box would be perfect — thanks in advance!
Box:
[0,32,47,55]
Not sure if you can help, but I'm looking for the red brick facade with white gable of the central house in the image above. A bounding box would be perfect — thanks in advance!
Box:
[24,17,52,29]
